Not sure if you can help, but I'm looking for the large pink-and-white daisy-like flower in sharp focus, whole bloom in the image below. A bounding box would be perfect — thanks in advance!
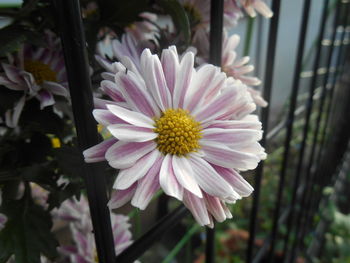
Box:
[84,46,266,226]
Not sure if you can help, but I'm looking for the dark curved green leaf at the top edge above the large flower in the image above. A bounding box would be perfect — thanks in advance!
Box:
[157,0,191,44]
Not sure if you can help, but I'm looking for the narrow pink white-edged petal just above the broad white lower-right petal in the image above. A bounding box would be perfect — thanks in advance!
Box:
[212,165,254,197]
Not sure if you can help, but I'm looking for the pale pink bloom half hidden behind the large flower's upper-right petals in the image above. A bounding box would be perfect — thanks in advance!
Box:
[221,31,268,107]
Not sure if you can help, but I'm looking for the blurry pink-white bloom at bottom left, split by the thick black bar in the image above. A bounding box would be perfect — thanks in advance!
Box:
[54,196,132,263]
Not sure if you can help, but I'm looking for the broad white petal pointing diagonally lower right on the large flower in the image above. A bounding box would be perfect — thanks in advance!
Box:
[189,155,236,198]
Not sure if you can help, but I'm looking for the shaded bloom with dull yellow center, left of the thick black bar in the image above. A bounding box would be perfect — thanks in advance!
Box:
[0,33,68,127]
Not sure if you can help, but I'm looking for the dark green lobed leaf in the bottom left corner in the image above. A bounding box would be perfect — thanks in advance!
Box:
[0,197,58,263]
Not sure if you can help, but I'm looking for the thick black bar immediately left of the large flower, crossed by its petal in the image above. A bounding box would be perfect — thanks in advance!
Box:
[53,0,115,263]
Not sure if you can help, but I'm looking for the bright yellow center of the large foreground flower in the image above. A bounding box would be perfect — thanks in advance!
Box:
[154,109,202,156]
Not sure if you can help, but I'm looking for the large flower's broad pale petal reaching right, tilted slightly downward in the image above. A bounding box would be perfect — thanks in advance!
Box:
[202,142,260,170]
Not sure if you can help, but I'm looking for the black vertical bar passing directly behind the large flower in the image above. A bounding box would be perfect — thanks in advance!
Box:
[205,0,224,263]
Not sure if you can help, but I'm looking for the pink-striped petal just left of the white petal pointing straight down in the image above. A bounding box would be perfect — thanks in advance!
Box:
[131,156,163,210]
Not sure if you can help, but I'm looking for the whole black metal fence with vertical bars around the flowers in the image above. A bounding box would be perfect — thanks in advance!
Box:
[54,0,350,263]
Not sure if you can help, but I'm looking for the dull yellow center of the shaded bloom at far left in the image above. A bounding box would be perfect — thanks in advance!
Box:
[24,60,57,85]
